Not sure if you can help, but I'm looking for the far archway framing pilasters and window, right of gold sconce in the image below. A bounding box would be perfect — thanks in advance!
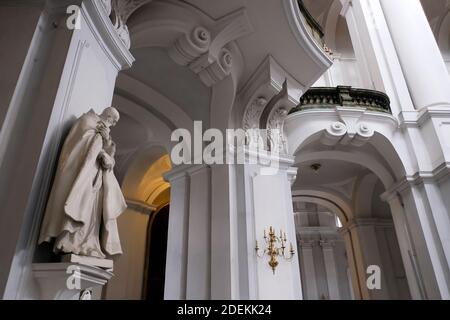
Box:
[293,190,360,300]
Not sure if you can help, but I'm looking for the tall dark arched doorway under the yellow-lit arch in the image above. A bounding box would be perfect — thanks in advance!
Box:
[143,205,169,301]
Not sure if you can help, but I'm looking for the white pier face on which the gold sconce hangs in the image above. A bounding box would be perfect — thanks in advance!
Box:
[243,151,302,300]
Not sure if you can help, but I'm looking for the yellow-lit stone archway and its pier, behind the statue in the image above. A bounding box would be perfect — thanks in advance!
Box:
[106,146,172,299]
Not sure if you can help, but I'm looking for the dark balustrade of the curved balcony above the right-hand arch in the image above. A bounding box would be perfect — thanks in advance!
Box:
[290,86,392,114]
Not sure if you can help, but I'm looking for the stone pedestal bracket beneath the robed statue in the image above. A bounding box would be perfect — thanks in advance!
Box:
[32,262,113,300]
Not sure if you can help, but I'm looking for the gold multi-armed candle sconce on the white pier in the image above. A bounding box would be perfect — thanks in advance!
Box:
[255,227,295,274]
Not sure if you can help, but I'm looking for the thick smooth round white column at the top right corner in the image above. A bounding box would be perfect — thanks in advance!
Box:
[380,0,450,109]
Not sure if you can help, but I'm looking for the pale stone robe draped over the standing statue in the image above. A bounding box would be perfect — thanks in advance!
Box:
[39,110,126,258]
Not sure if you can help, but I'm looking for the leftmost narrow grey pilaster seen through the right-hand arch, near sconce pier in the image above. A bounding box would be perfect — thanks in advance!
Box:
[299,241,319,300]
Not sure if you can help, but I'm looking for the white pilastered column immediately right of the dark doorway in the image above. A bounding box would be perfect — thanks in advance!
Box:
[164,165,214,300]
